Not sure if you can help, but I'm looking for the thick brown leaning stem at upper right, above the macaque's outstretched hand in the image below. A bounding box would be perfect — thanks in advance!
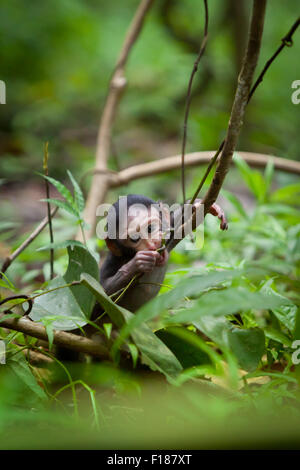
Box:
[203,0,266,214]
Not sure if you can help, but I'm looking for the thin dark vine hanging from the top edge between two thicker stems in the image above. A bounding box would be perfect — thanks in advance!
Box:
[181,0,208,204]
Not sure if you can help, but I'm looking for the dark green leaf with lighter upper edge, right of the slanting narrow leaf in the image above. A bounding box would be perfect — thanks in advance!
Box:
[155,326,212,369]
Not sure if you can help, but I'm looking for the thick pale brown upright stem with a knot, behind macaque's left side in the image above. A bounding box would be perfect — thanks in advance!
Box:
[82,0,153,239]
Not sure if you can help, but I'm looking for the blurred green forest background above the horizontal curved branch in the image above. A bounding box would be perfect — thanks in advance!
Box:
[0,0,300,190]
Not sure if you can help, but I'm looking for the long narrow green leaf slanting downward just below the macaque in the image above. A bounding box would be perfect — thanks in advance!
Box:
[81,274,182,378]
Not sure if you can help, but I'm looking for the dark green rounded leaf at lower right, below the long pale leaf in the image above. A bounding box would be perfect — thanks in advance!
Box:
[227,328,265,371]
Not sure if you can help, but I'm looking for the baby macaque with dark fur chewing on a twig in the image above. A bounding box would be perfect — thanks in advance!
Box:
[100,194,228,312]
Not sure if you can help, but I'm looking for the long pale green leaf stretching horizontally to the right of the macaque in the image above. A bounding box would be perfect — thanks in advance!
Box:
[168,287,292,324]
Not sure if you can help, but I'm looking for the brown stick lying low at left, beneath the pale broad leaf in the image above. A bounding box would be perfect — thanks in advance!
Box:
[0,314,109,359]
